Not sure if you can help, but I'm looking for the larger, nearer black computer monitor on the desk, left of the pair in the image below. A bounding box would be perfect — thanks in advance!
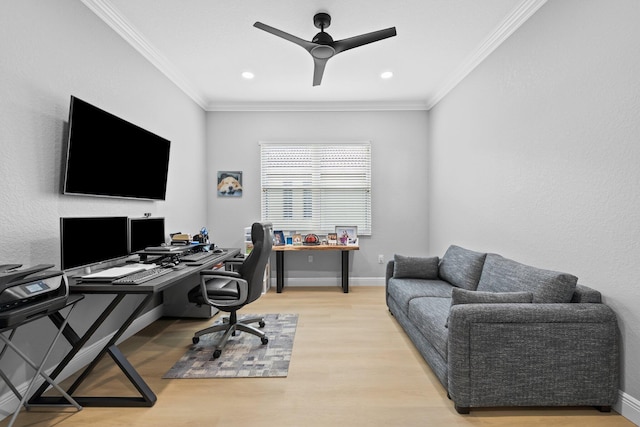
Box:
[60,216,129,270]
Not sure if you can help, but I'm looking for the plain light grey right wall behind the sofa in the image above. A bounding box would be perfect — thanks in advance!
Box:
[429,0,640,423]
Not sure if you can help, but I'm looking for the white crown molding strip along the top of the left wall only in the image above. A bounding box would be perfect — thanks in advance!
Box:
[81,0,207,109]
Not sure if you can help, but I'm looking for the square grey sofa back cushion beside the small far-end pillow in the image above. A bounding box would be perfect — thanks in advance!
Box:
[438,245,487,291]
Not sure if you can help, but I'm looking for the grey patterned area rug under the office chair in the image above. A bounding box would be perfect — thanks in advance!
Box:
[163,314,298,378]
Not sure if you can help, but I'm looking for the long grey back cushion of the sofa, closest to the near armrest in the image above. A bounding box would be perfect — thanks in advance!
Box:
[477,254,578,303]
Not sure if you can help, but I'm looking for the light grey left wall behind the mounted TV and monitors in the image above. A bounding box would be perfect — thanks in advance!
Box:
[0,0,206,402]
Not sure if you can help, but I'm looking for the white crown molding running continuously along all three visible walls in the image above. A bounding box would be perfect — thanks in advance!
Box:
[81,0,547,112]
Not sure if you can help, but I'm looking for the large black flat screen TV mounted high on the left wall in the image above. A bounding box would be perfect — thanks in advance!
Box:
[62,96,171,200]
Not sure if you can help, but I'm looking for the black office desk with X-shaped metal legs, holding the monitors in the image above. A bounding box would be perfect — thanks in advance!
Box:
[29,248,240,407]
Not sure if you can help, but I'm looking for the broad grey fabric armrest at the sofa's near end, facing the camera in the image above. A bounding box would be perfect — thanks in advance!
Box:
[448,303,620,408]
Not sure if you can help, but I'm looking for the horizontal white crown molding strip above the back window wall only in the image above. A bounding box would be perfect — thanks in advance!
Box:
[206,101,427,112]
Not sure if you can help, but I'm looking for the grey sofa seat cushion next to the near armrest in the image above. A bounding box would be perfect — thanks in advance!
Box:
[408,297,451,360]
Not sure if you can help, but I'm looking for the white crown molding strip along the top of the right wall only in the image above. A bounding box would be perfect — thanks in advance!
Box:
[426,0,547,110]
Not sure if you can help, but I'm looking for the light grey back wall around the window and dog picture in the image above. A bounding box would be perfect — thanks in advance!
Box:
[207,111,428,285]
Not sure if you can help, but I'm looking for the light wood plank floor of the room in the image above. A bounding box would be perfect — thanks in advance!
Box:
[0,286,633,427]
